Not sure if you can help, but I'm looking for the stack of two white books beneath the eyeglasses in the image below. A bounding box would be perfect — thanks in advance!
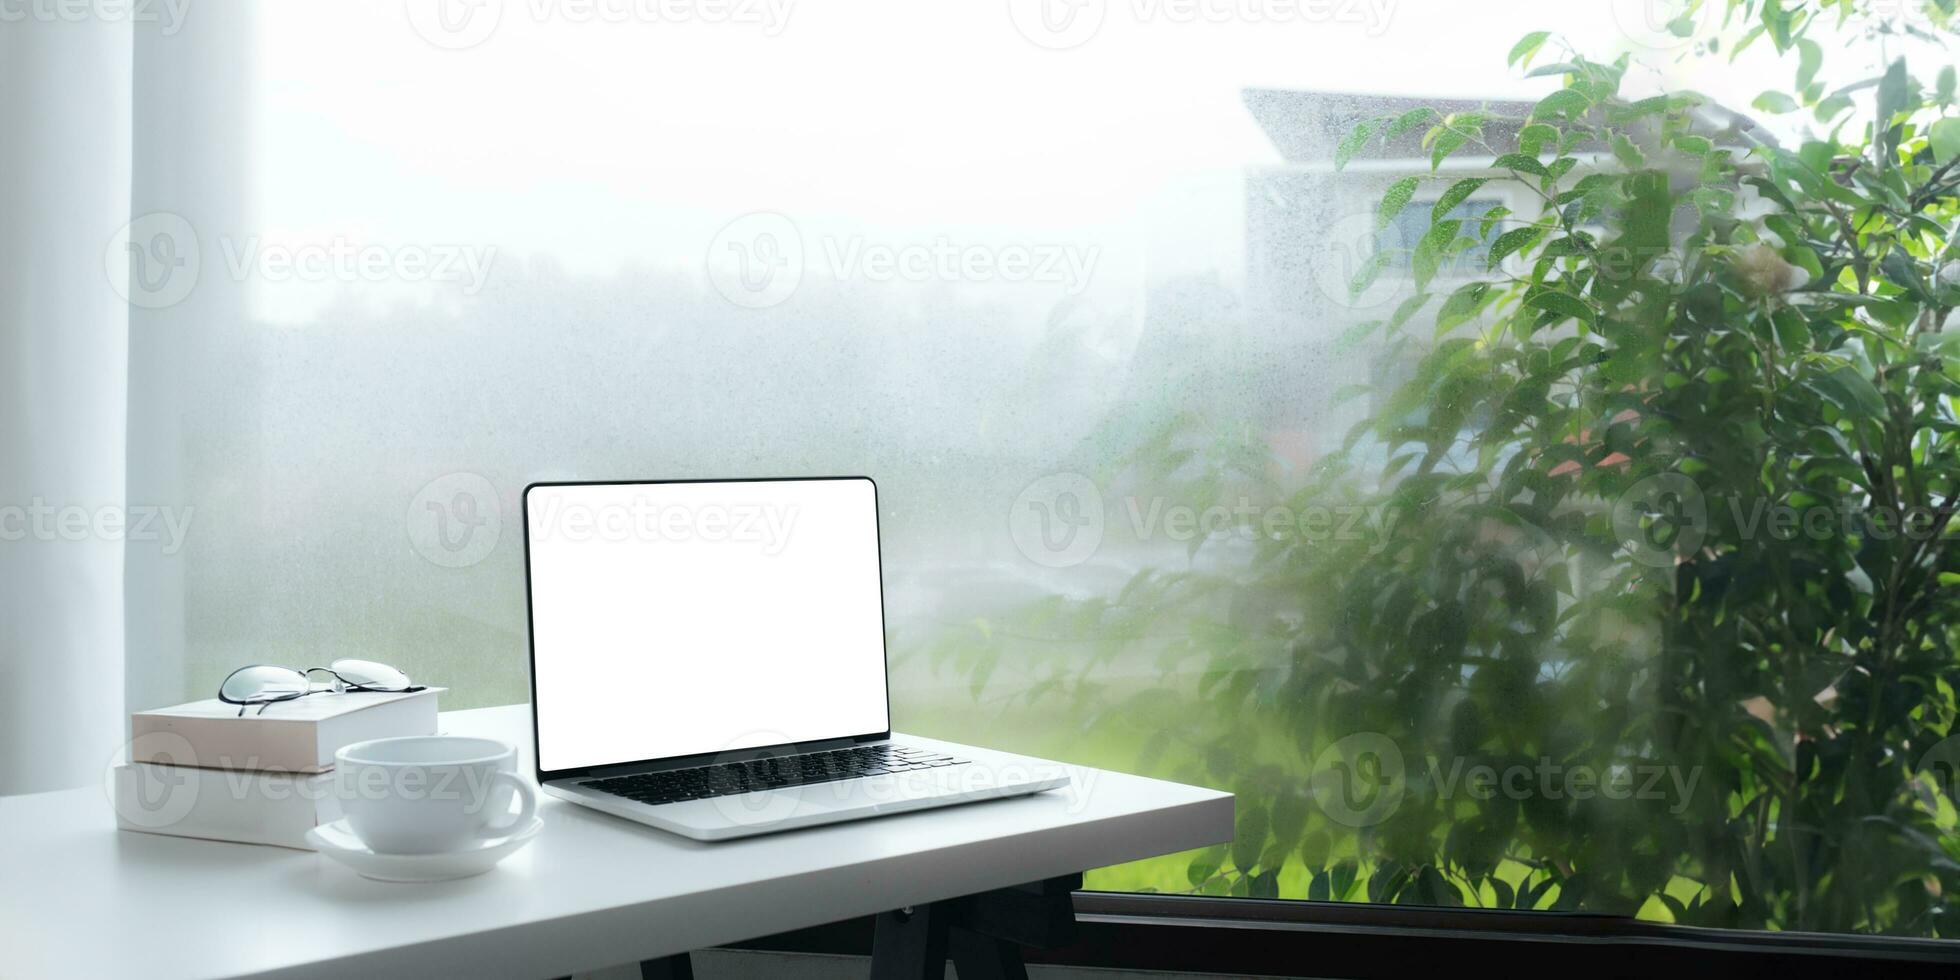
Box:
[110,688,443,851]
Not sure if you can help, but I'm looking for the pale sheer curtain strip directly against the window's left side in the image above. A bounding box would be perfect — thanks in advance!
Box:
[123,4,256,721]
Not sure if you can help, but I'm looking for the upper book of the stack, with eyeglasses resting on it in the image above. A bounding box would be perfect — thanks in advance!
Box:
[129,688,443,772]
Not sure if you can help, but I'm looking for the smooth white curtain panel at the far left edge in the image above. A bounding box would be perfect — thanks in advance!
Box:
[0,8,131,806]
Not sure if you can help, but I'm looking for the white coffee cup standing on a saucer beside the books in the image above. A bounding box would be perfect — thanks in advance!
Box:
[333,735,537,855]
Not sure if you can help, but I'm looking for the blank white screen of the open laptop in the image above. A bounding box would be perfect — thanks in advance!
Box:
[525,478,890,772]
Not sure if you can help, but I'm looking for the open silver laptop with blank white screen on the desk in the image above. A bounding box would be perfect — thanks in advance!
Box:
[523,476,1068,841]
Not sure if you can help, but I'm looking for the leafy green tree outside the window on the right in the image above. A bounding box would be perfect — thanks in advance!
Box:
[929,0,1960,935]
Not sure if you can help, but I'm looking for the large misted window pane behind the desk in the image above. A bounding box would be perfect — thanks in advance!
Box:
[129,0,1960,937]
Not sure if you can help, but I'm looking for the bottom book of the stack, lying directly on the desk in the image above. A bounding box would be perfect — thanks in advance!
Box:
[114,762,341,851]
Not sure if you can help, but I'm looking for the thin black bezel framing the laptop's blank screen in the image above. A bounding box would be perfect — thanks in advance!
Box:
[519,476,892,782]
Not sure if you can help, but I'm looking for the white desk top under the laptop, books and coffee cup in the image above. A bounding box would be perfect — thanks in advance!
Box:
[0,706,1233,980]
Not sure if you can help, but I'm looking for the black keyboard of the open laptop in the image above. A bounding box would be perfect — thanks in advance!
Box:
[580,743,964,806]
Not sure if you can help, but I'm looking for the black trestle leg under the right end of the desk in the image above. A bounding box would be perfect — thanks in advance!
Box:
[870,874,1082,980]
